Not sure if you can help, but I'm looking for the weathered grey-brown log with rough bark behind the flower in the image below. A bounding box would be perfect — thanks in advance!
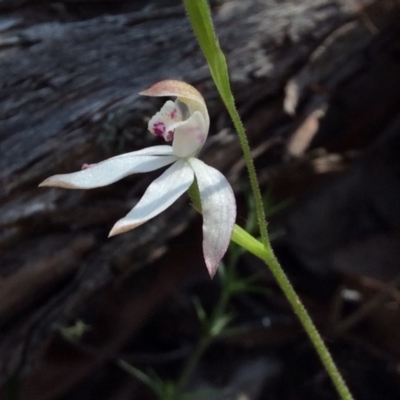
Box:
[0,0,398,398]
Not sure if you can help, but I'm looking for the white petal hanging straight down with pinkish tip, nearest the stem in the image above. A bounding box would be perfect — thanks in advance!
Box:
[188,158,236,277]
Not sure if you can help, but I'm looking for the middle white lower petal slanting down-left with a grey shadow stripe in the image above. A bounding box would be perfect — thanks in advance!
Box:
[109,160,194,236]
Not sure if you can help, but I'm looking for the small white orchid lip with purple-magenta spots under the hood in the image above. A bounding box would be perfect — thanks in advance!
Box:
[148,100,182,142]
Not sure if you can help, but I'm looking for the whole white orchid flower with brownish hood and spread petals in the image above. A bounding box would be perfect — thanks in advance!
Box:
[39,80,236,276]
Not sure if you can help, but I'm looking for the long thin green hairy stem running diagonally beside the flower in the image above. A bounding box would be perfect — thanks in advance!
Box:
[184,0,353,400]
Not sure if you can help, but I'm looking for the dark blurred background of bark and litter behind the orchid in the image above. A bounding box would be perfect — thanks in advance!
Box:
[0,0,400,400]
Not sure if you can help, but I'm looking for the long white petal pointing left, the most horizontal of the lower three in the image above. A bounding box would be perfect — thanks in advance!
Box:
[39,146,176,189]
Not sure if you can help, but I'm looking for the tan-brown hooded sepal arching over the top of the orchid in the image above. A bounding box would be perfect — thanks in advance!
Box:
[140,80,210,133]
